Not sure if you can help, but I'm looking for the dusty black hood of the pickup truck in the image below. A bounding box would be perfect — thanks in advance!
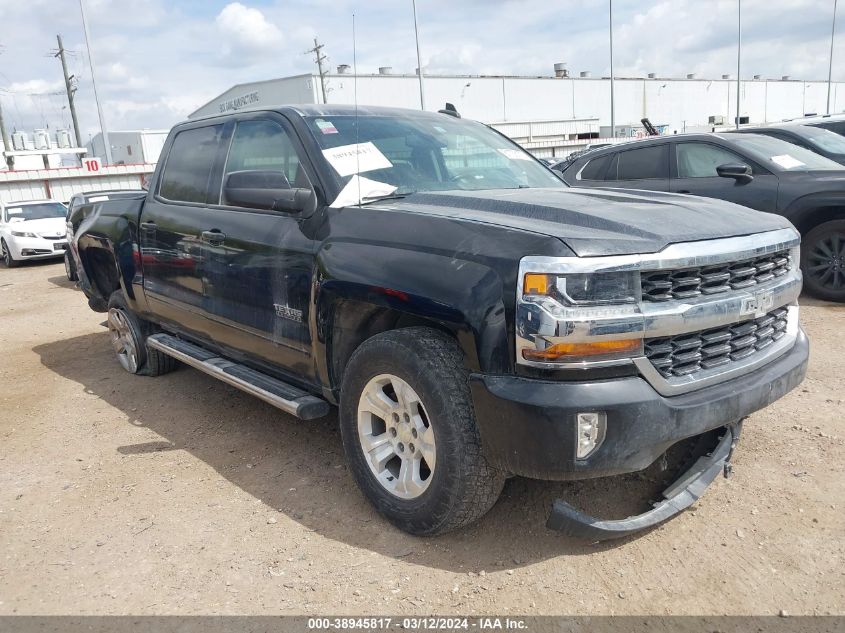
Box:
[390,187,791,257]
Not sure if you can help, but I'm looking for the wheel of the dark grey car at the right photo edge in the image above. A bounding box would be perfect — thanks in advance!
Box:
[801,220,845,302]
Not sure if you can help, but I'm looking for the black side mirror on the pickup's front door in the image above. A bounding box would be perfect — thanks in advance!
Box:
[222,169,317,213]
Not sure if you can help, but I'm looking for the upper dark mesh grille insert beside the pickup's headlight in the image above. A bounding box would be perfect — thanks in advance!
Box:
[641,251,792,302]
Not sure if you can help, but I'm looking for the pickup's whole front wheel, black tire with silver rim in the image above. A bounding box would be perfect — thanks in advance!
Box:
[340,327,505,535]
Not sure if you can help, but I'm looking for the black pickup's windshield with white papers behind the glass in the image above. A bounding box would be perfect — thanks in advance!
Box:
[306,114,566,198]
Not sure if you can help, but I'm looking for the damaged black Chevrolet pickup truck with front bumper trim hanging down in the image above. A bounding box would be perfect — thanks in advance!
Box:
[68,105,808,540]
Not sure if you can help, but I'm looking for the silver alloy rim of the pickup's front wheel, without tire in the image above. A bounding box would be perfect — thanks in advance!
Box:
[358,374,437,499]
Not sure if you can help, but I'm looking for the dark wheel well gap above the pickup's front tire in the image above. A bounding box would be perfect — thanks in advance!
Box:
[329,300,462,389]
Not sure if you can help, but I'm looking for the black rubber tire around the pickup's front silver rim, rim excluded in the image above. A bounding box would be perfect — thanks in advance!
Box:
[340,327,505,535]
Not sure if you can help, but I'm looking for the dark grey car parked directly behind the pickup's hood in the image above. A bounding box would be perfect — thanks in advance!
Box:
[563,133,845,301]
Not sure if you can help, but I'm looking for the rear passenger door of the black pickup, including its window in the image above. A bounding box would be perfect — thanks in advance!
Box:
[138,123,226,324]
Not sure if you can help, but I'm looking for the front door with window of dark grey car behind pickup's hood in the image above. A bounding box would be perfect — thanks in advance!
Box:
[670,141,778,213]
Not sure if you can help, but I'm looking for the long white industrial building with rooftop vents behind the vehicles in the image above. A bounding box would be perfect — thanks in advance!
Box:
[190,64,845,156]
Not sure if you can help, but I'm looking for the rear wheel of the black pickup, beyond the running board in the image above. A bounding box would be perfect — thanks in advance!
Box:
[107,290,177,376]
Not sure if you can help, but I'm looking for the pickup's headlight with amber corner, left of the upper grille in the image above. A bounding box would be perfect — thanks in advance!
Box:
[522,272,640,306]
